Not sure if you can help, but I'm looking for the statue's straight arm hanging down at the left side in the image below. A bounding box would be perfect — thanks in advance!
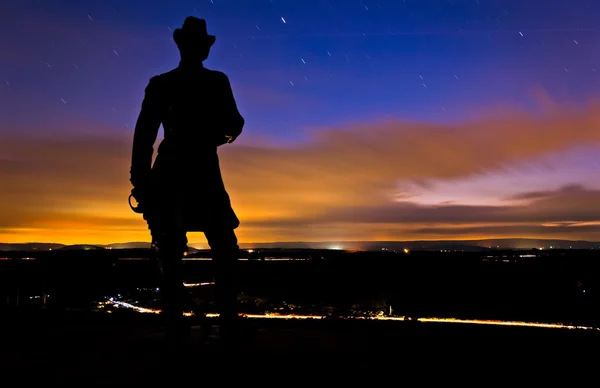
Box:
[130,77,161,187]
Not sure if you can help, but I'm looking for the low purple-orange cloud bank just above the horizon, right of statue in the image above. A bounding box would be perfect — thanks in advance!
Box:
[234,185,600,240]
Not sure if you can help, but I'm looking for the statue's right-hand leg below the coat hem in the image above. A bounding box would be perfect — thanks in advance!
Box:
[204,229,239,326]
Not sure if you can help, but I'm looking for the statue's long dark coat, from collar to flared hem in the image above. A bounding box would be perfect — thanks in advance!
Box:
[131,62,244,231]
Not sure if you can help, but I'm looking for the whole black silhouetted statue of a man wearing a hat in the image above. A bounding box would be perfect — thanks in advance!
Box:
[131,16,244,348]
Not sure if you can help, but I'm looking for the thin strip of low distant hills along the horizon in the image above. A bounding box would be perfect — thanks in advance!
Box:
[0,238,600,253]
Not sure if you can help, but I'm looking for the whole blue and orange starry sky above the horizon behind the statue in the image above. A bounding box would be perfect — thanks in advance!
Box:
[0,0,600,246]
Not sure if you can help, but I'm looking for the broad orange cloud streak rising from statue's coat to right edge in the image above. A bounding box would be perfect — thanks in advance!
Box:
[222,100,600,216]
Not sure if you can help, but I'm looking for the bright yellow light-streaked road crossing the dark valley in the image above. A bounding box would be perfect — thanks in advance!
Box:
[107,298,600,331]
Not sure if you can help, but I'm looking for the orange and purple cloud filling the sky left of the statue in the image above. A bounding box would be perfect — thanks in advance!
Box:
[0,123,131,227]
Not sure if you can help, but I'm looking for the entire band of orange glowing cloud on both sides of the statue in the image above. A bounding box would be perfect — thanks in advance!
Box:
[0,101,600,243]
